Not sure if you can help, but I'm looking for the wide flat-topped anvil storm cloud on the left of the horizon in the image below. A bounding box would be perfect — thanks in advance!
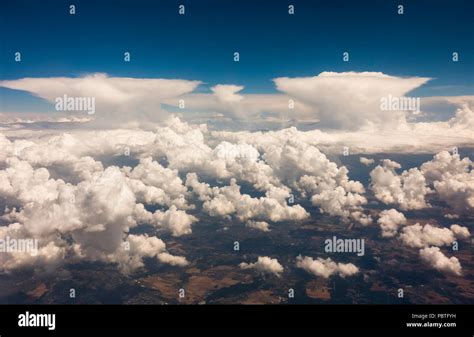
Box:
[0,73,201,126]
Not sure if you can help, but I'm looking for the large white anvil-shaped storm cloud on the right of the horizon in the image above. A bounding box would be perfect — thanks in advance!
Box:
[274,72,430,129]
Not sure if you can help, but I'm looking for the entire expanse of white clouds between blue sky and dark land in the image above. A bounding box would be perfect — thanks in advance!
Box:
[0,72,474,278]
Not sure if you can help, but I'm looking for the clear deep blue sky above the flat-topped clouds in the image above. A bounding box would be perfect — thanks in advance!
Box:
[0,0,474,110]
